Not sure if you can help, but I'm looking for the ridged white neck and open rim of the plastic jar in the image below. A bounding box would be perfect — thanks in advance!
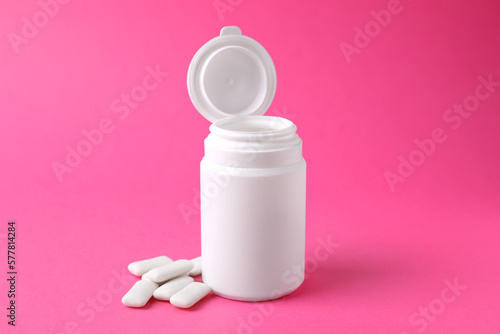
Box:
[205,116,302,168]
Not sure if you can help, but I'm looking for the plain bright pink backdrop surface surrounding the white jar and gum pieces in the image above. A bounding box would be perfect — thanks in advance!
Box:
[0,0,500,334]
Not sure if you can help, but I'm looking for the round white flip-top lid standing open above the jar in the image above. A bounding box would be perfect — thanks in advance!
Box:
[187,26,276,122]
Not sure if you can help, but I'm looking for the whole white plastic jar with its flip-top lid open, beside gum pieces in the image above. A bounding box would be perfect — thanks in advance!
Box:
[188,27,306,301]
